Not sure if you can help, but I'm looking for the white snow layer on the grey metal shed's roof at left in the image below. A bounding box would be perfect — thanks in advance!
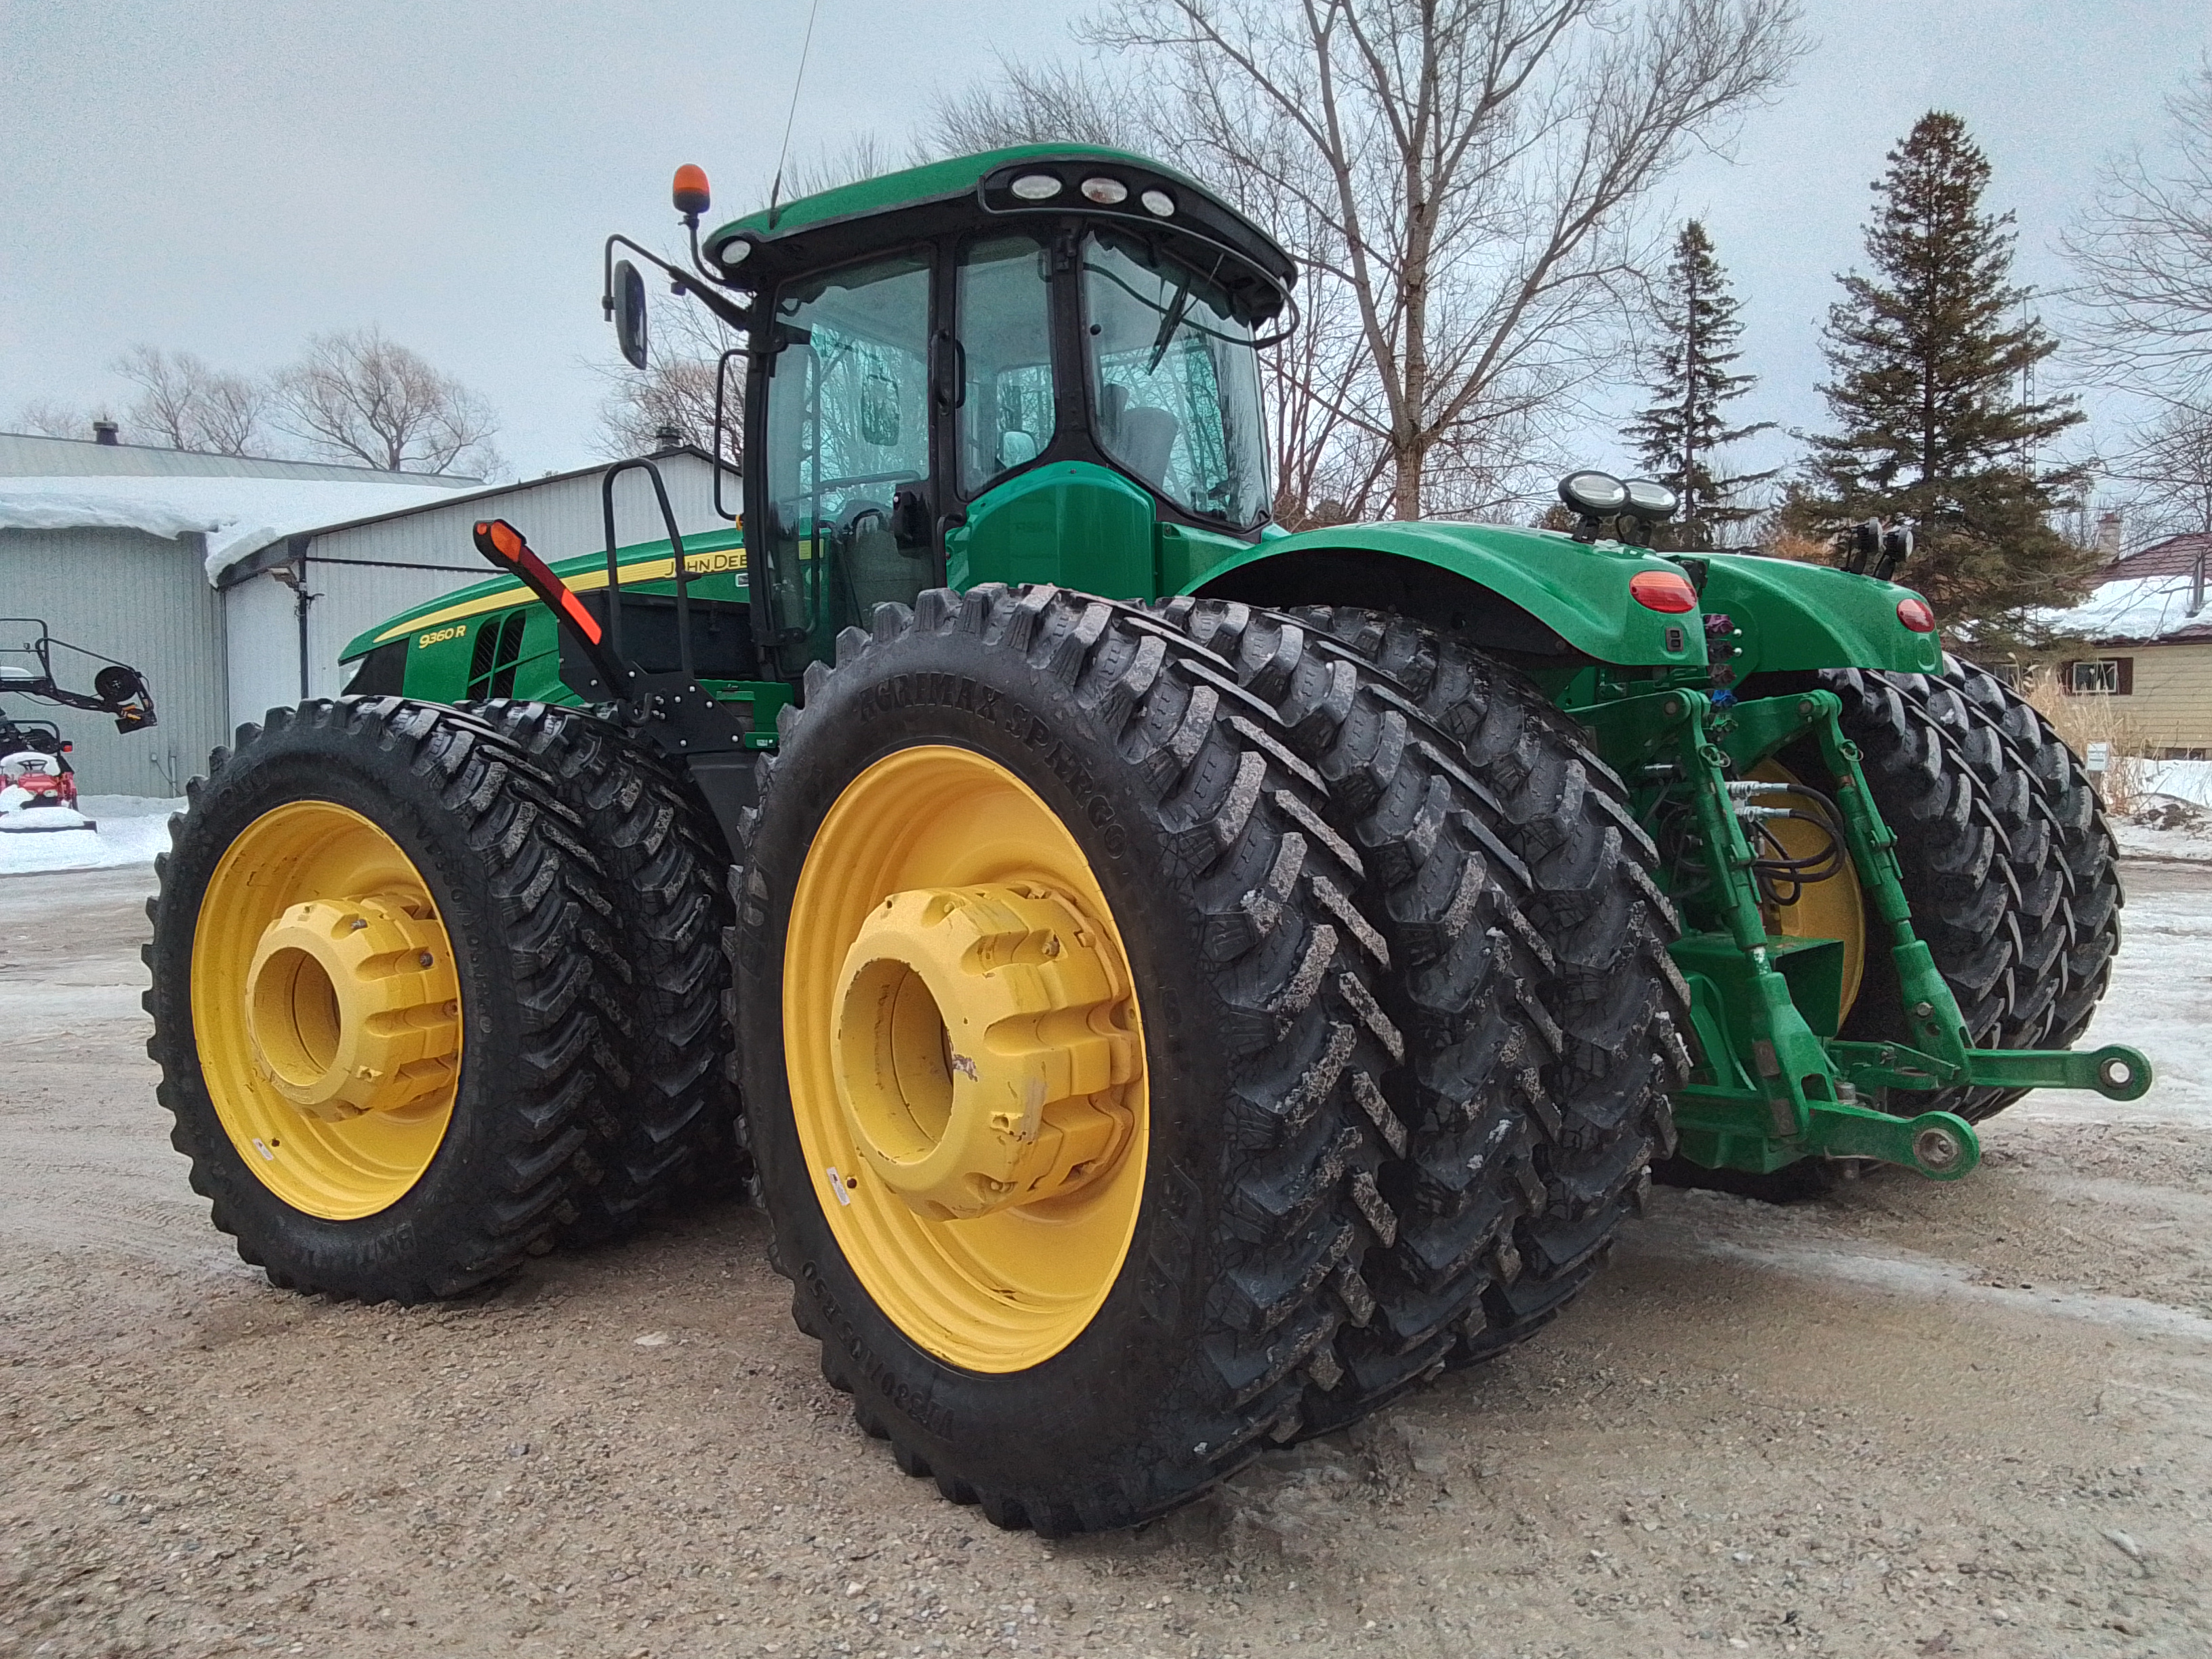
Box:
[0,473,480,581]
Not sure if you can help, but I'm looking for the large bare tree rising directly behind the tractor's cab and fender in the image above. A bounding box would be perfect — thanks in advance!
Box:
[1086,0,1803,518]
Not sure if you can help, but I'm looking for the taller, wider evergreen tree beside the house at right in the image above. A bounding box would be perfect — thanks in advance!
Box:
[1790,110,2095,648]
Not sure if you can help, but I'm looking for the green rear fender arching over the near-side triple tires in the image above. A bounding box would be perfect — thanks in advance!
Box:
[1164,522,1706,668]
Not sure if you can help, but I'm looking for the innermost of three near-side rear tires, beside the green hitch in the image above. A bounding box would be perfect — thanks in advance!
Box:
[1294,606,1690,1365]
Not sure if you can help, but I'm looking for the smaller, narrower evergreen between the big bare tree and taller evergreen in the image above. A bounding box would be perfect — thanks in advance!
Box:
[1622,219,1774,548]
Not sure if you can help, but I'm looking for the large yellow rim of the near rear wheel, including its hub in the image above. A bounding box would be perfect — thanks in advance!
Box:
[783,745,1148,1374]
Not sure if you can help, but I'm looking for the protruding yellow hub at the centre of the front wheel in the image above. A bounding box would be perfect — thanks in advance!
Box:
[245,894,460,1122]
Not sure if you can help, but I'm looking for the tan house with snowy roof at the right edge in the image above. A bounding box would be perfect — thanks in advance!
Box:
[2044,533,2212,761]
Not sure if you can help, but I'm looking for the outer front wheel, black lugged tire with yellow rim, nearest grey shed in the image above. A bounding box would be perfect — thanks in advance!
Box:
[146,697,613,1303]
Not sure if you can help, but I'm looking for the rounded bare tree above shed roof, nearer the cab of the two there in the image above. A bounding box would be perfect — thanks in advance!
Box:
[274,327,500,476]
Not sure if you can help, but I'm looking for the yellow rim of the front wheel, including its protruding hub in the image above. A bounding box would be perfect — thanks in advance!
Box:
[192,801,460,1221]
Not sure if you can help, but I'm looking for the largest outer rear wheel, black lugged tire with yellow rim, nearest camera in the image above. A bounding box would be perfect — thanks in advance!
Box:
[732,584,1396,1535]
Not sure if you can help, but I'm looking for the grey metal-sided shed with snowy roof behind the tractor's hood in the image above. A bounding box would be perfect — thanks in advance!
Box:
[0,434,737,796]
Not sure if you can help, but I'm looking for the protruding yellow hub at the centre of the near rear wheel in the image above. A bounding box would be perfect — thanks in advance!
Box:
[832,882,1143,1221]
